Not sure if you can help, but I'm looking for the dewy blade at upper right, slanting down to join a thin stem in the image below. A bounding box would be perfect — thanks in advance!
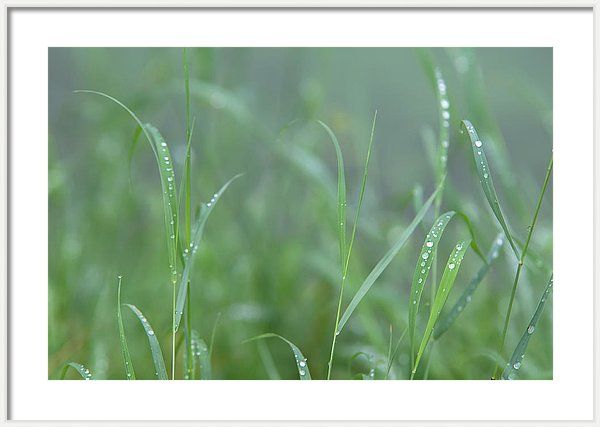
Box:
[462,120,521,259]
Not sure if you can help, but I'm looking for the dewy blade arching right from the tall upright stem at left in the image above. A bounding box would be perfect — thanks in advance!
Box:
[175,174,242,330]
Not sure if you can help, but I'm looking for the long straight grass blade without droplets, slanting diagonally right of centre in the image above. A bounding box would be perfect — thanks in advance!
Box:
[336,182,443,334]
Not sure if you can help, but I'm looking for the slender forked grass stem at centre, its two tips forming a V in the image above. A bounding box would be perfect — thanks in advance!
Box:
[319,110,377,379]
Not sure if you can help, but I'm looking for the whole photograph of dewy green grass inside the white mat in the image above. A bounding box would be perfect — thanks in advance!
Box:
[48,46,552,384]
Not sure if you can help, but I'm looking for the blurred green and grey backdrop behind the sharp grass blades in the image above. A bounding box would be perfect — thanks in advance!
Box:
[48,48,552,379]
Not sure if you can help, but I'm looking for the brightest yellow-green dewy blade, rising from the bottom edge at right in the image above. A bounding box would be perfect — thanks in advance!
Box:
[411,240,470,378]
